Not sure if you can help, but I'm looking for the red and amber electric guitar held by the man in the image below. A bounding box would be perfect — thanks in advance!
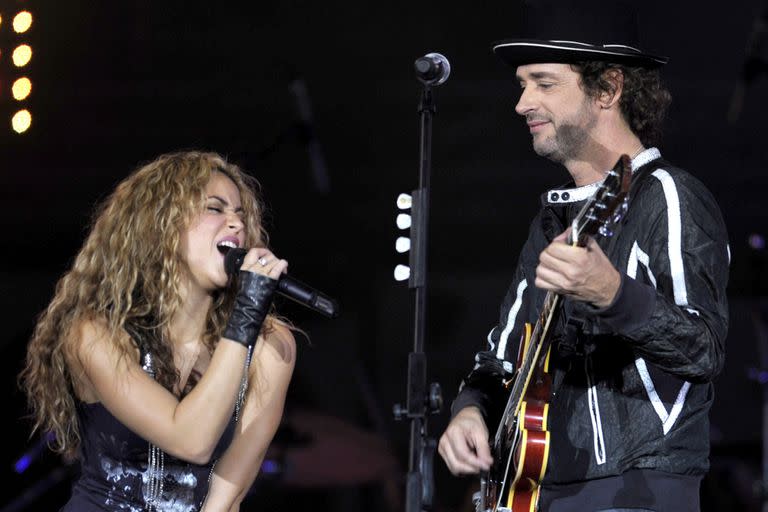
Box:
[475,155,632,512]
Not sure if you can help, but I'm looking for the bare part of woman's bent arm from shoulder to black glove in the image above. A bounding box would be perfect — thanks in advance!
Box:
[73,320,252,464]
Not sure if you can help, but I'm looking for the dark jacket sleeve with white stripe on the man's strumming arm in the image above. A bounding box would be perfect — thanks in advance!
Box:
[451,222,538,425]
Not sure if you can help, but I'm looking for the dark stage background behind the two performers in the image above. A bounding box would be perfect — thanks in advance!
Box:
[0,0,768,512]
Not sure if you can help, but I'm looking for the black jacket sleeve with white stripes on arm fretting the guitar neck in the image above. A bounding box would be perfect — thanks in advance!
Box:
[584,169,730,381]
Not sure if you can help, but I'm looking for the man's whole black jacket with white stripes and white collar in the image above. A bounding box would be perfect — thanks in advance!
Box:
[452,148,730,485]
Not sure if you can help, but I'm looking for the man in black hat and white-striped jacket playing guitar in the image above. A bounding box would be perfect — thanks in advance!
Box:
[439,0,730,512]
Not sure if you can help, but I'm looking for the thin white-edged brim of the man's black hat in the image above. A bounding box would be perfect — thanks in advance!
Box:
[492,39,669,68]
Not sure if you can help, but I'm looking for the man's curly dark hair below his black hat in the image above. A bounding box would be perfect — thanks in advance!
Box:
[574,61,672,147]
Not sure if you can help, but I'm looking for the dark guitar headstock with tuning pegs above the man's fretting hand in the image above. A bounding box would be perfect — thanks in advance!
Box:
[569,155,632,246]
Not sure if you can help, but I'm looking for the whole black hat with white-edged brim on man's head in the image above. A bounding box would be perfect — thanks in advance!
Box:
[492,0,669,68]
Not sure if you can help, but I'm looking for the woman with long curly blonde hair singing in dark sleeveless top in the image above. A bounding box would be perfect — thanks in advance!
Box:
[20,152,296,512]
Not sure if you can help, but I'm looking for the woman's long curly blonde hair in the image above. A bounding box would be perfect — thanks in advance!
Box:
[19,151,272,458]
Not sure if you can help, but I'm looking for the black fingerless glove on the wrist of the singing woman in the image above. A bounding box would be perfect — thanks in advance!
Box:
[222,271,277,347]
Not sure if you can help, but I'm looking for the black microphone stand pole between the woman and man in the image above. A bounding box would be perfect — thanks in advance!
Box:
[393,83,443,512]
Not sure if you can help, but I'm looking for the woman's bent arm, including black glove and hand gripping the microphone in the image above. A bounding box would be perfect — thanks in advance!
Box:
[70,248,288,464]
